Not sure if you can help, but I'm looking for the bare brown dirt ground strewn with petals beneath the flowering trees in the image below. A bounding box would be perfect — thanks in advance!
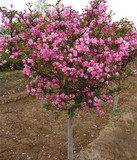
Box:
[0,71,137,160]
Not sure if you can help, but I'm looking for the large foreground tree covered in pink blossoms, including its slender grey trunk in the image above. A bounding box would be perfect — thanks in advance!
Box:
[0,0,137,159]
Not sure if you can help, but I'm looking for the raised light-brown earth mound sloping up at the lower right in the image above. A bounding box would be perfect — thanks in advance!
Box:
[78,99,137,160]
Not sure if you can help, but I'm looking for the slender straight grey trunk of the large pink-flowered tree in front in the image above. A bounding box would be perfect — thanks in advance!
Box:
[68,117,73,160]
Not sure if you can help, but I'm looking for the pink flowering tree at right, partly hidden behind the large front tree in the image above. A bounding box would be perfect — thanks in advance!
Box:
[113,19,137,111]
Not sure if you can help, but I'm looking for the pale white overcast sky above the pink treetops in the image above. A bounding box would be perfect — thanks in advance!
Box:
[0,0,137,27]
